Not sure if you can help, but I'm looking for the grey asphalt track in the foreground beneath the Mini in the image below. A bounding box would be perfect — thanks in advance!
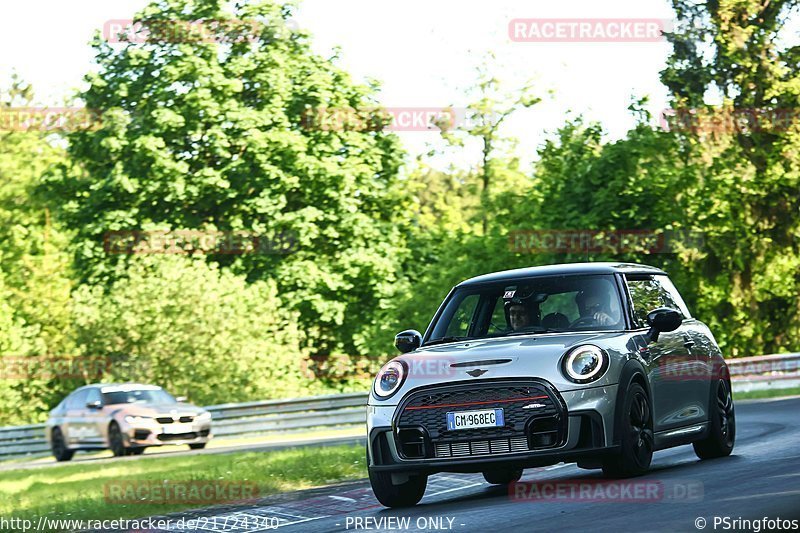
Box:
[119,398,800,533]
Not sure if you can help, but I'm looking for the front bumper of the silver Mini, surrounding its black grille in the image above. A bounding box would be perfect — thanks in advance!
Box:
[367,380,618,473]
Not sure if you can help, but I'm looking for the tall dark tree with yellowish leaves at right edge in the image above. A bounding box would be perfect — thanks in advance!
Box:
[662,0,800,355]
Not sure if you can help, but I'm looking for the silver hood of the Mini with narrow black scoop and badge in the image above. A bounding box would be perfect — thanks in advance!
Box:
[373,331,628,405]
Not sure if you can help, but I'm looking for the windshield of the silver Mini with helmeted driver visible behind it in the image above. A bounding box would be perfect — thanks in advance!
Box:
[432,274,624,344]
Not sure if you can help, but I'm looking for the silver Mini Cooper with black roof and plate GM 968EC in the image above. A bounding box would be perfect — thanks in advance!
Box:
[367,263,736,507]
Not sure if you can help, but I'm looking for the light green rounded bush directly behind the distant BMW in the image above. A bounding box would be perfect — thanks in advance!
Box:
[74,256,315,405]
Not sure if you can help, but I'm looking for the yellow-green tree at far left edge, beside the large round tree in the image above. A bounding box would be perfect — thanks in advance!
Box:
[0,76,80,424]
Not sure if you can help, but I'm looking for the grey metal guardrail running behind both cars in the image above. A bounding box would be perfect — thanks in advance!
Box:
[0,353,800,459]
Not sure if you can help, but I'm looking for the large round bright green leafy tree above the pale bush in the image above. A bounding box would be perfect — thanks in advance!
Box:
[52,0,404,354]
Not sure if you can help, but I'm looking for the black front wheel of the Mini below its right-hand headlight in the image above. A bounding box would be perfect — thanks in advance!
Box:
[603,383,655,478]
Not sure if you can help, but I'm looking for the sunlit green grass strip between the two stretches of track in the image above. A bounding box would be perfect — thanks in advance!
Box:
[0,446,367,524]
